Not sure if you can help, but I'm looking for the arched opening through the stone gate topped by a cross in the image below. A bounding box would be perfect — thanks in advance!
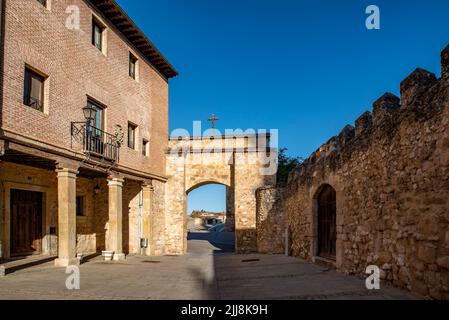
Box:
[186,181,235,253]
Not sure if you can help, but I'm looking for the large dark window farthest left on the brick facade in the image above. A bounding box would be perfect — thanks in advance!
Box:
[23,68,45,112]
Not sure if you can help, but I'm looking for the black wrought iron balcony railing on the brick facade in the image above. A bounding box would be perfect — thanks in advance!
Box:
[71,122,120,162]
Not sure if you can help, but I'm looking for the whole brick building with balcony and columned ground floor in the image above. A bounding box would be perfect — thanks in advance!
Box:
[0,0,177,266]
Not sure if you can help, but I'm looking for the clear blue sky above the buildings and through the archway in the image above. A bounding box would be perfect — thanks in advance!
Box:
[117,0,449,215]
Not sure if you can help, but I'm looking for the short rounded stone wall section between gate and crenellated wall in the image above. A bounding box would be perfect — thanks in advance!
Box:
[256,187,285,254]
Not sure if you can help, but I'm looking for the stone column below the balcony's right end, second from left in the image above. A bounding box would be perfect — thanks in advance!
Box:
[106,177,125,261]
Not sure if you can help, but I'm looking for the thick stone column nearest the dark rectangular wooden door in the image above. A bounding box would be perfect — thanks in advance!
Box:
[55,167,79,267]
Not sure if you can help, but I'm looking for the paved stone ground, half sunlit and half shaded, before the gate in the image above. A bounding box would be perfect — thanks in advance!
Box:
[0,233,413,300]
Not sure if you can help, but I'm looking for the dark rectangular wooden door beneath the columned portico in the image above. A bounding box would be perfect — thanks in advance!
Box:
[11,189,42,256]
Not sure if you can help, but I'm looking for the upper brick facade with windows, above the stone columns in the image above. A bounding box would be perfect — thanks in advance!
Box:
[1,0,172,177]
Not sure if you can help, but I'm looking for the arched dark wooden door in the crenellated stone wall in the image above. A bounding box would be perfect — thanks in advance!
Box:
[318,185,337,260]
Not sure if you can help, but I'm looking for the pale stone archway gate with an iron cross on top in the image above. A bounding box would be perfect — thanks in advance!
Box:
[165,134,277,254]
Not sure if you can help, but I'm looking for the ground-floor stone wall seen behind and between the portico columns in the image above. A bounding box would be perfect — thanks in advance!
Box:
[0,162,166,257]
